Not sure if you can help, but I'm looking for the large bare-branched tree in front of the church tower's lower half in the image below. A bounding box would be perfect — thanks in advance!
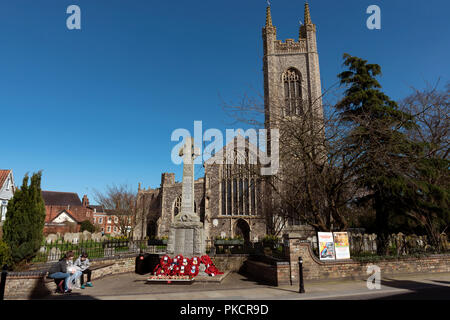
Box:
[220,82,357,235]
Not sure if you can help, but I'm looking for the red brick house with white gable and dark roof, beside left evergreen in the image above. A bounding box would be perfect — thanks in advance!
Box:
[42,191,93,234]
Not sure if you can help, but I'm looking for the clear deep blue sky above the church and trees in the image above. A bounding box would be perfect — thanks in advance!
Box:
[0,0,450,202]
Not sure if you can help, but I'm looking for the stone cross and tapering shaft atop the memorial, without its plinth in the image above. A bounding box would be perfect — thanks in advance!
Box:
[176,137,200,221]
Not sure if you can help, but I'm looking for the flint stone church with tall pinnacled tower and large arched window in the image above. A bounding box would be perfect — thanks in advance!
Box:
[134,3,323,241]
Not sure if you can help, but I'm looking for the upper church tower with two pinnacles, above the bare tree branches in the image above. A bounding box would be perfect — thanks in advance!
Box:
[263,3,323,131]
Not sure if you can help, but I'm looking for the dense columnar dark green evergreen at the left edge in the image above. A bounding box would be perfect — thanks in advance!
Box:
[3,172,45,265]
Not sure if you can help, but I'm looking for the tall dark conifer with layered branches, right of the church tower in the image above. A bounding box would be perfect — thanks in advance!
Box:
[336,54,417,254]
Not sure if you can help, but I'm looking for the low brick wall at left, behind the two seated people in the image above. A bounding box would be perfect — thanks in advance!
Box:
[5,255,136,299]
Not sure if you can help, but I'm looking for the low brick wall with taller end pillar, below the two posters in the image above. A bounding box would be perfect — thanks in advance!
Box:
[287,237,450,283]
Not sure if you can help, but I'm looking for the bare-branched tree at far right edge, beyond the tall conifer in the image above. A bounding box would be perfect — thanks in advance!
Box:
[401,81,450,249]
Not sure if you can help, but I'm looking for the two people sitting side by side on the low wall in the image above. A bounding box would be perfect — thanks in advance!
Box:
[48,251,92,293]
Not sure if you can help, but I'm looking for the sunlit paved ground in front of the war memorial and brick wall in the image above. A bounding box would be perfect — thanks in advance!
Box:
[44,273,450,300]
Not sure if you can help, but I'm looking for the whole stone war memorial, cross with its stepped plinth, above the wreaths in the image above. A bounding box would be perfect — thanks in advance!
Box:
[167,137,205,257]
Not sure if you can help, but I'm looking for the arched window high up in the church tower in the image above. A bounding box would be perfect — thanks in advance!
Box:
[283,68,303,116]
